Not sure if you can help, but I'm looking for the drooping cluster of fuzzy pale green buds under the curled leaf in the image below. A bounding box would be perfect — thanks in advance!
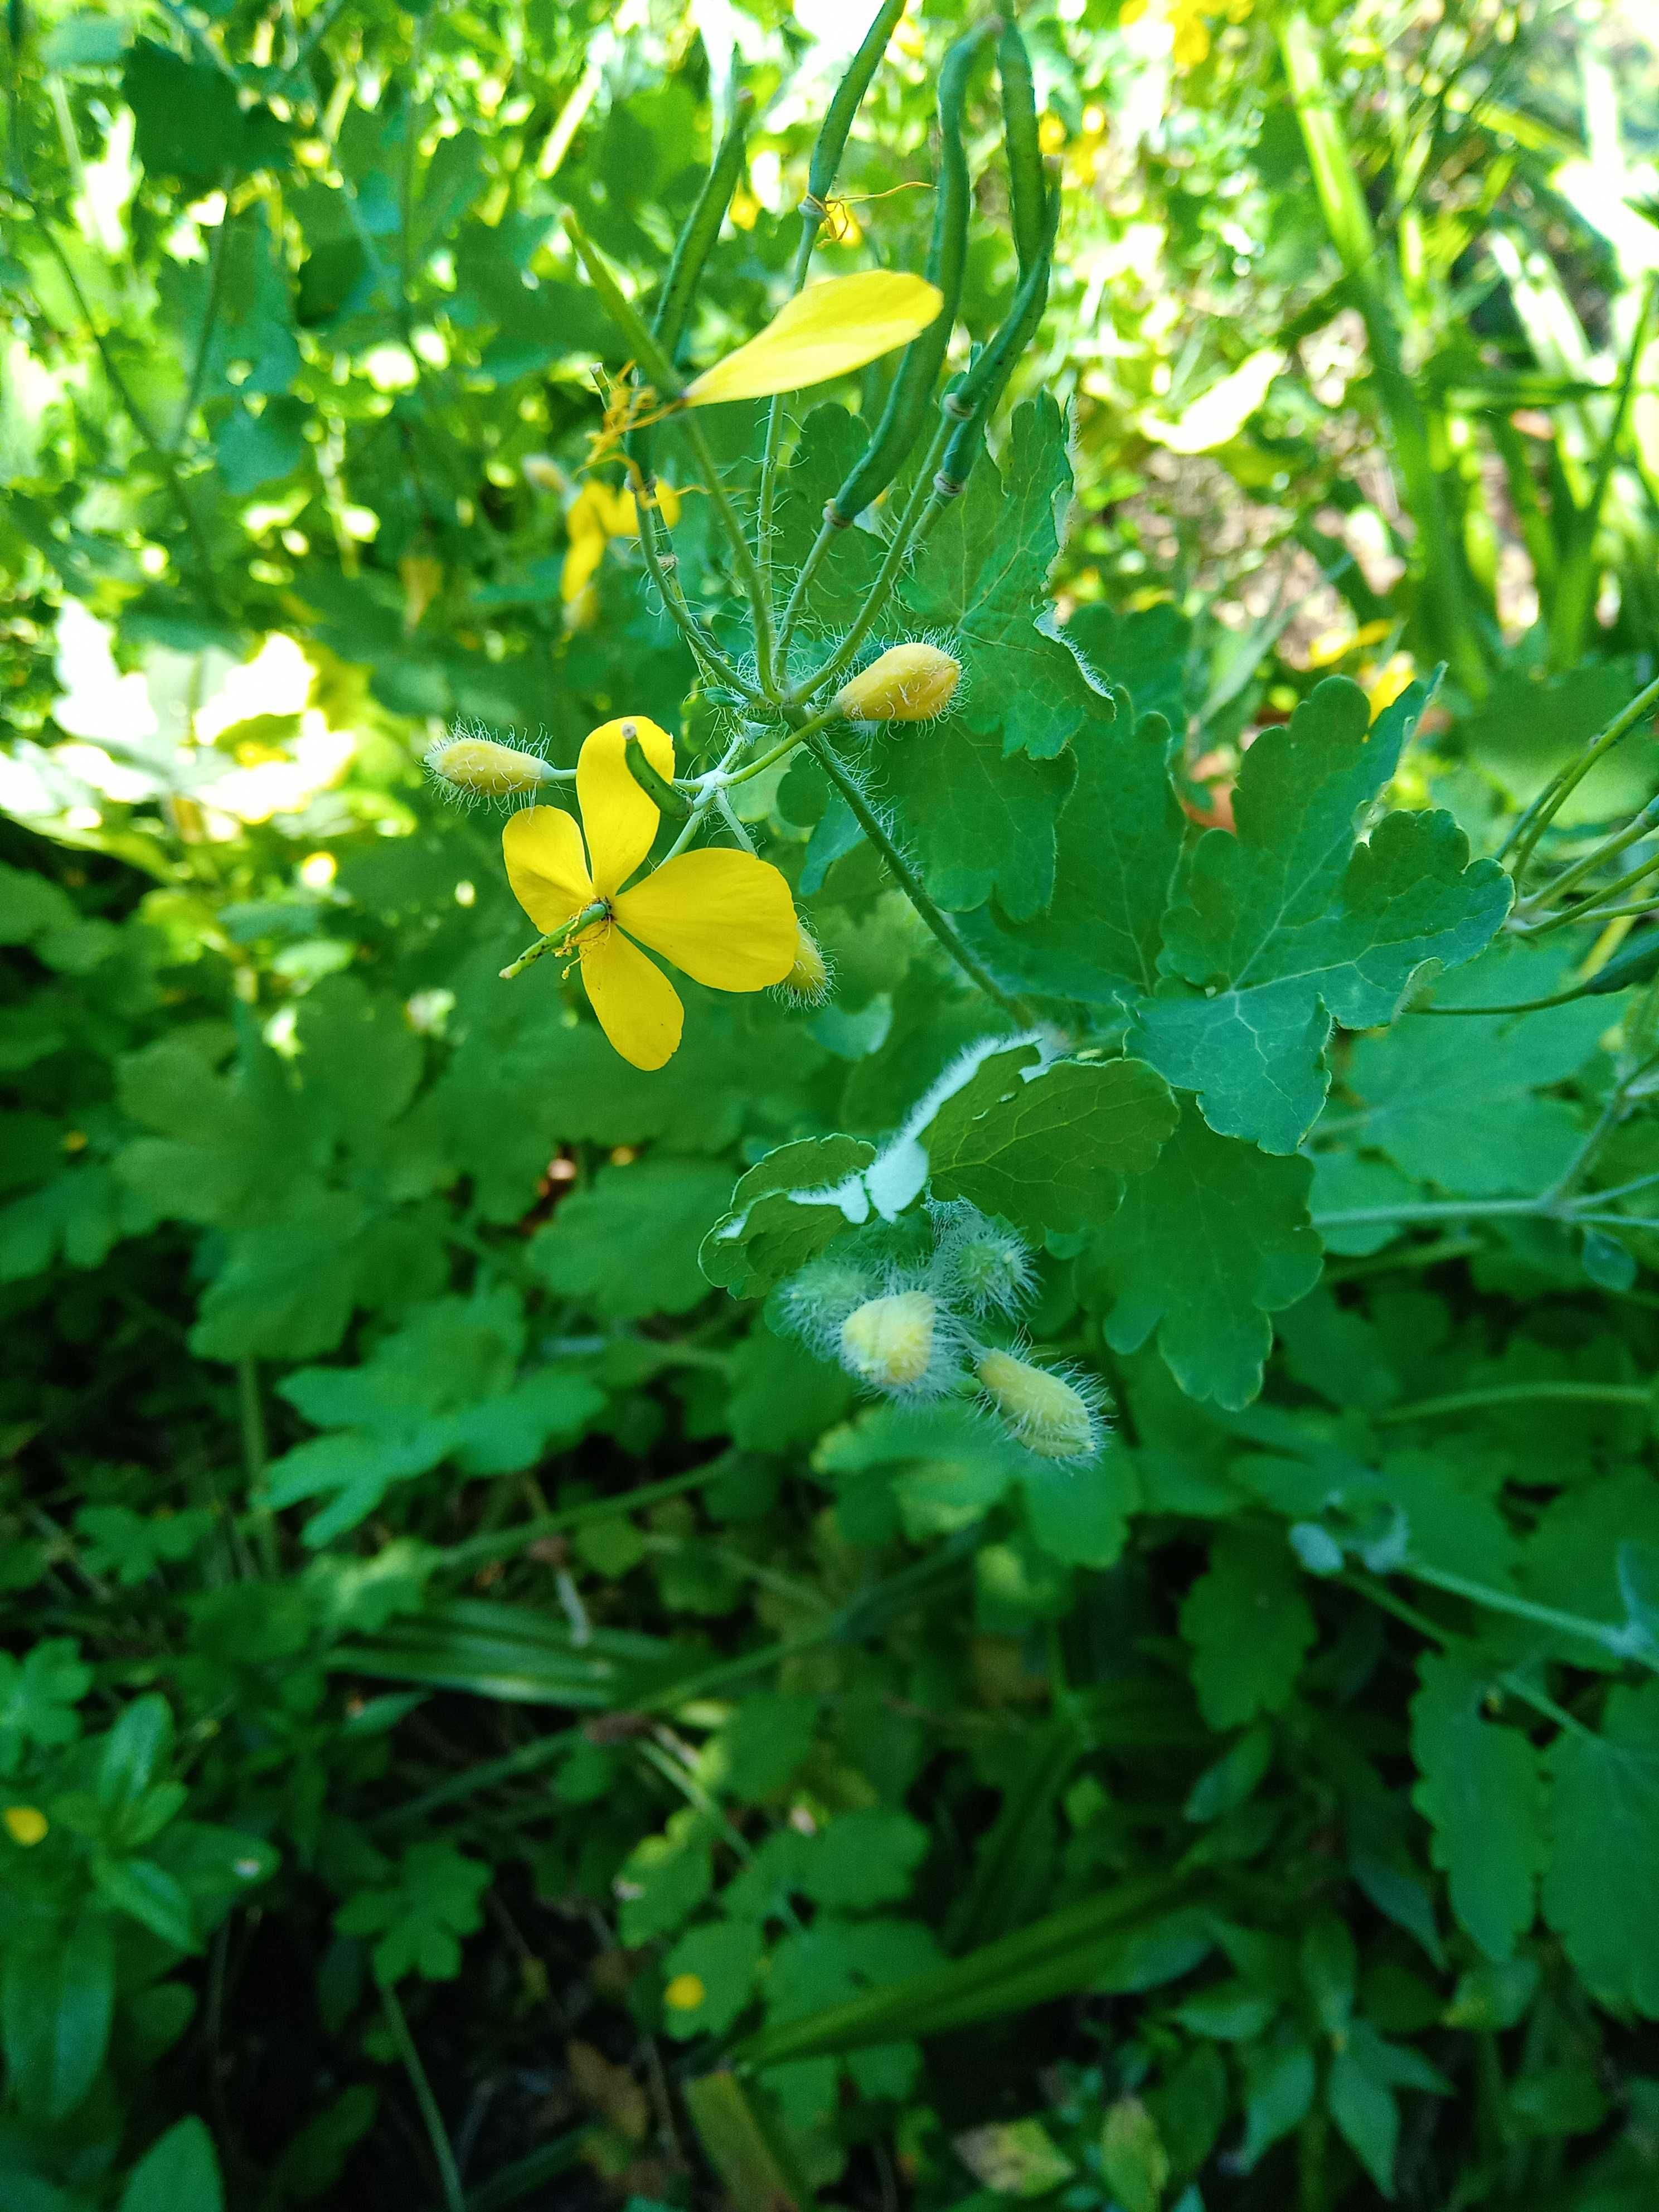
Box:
[779,1199,1106,1462]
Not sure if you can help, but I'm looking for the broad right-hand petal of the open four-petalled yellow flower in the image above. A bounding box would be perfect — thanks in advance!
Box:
[615,847,801,991]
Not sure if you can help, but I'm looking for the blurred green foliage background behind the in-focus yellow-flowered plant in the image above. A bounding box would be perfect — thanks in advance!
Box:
[0,0,1659,2212]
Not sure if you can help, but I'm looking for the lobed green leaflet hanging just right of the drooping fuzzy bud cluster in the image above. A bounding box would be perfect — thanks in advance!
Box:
[1077,1102,1321,1407]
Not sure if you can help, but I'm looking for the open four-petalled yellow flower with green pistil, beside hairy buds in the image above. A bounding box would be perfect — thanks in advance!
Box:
[502,715,801,1069]
